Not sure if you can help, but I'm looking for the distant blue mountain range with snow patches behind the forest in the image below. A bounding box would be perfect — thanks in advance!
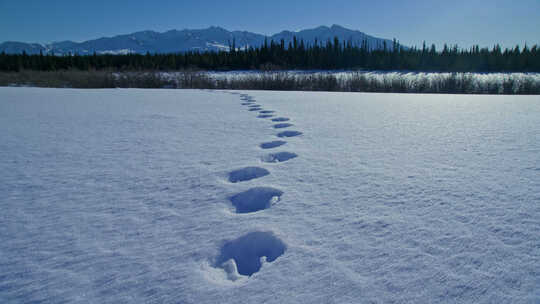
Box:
[0,24,398,55]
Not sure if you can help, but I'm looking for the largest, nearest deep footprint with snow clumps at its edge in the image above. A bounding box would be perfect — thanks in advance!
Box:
[214,231,287,281]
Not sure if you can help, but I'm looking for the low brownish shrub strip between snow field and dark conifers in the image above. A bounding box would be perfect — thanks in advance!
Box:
[0,70,540,94]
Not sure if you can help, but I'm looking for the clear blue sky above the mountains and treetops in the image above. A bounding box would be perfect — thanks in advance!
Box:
[0,0,540,47]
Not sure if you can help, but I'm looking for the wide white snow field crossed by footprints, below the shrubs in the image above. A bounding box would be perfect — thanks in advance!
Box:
[0,88,540,303]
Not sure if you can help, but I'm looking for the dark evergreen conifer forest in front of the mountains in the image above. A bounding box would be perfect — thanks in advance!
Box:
[0,38,540,72]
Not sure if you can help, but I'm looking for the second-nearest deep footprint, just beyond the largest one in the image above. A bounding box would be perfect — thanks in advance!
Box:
[230,187,283,213]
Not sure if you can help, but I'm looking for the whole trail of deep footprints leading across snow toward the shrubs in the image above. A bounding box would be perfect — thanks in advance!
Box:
[214,93,302,281]
